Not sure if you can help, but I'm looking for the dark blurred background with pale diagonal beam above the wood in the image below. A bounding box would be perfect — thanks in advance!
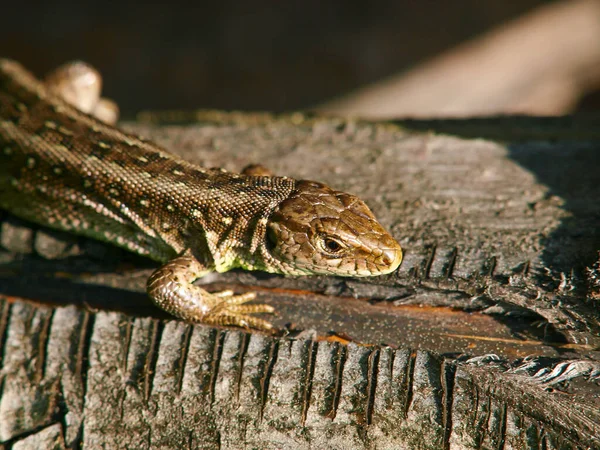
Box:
[0,0,600,117]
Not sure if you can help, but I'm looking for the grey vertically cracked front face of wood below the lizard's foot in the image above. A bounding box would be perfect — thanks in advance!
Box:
[0,302,600,449]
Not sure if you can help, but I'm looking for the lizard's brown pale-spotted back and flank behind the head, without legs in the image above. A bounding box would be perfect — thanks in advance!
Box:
[0,60,296,270]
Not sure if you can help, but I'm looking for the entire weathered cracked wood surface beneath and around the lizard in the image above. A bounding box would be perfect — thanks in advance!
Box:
[0,112,600,449]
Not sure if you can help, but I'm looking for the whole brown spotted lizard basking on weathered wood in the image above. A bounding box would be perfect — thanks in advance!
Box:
[0,59,402,332]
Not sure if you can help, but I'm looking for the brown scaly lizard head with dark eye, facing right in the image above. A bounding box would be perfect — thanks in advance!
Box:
[267,180,402,277]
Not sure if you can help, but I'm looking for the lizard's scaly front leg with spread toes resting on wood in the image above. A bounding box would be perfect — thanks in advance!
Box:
[147,250,274,331]
